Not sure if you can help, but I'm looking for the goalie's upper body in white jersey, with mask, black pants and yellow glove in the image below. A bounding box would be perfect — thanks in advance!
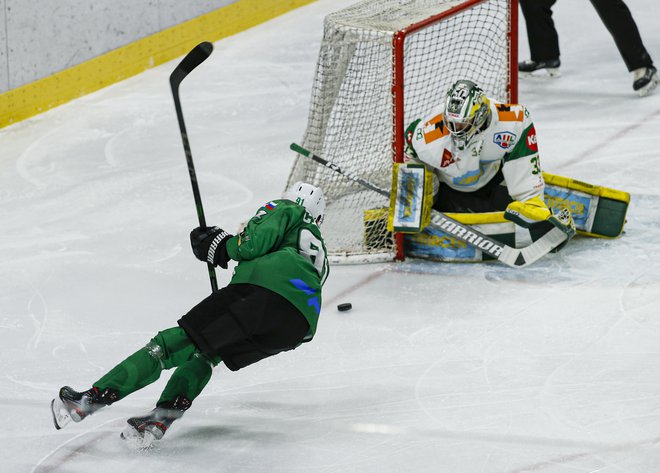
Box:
[405,80,575,241]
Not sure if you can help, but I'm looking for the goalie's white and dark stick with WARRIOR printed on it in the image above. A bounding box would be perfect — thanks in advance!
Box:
[290,143,567,268]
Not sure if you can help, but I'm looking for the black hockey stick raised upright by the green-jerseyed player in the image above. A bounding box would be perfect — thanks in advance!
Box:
[170,41,218,292]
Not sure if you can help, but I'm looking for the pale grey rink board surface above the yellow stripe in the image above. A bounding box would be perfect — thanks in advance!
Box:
[0,0,238,93]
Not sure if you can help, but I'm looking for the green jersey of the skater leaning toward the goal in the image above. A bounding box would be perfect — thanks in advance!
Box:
[227,200,329,340]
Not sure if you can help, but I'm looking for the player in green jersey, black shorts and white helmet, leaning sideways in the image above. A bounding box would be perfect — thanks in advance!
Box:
[51,182,329,447]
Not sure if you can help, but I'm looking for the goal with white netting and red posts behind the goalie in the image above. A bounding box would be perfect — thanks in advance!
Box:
[287,0,518,262]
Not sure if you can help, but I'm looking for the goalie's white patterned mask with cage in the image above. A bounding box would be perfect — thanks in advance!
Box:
[444,80,490,149]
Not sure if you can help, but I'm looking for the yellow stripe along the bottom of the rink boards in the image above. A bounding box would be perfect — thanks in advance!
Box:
[0,0,315,128]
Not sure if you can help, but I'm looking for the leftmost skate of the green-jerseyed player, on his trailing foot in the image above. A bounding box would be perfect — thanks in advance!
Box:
[50,386,117,430]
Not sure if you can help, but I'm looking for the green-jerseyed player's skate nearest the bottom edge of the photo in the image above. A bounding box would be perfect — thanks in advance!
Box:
[120,396,191,448]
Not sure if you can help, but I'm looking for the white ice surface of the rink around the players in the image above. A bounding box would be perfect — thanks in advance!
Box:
[0,0,660,473]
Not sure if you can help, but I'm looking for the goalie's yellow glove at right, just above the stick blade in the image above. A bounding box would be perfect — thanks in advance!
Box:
[504,197,575,250]
